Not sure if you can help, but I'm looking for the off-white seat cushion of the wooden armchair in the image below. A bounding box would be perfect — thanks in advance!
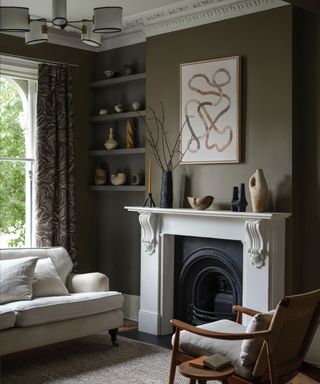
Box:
[179,320,252,378]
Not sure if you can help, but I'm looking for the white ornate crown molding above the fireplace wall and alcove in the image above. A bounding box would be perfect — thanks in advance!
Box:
[100,0,289,51]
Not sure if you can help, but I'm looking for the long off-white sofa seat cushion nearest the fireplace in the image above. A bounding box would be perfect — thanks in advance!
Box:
[3,291,123,327]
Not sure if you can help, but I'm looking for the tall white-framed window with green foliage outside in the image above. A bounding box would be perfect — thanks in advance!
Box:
[0,56,37,248]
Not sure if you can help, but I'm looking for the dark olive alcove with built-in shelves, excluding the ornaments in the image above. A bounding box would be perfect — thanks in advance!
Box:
[87,43,146,300]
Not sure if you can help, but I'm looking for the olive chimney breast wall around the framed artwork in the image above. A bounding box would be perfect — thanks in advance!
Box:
[146,6,297,291]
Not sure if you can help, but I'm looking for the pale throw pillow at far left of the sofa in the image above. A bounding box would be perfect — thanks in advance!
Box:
[0,257,38,304]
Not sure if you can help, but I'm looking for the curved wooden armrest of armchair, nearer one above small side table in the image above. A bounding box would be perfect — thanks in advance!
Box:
[170,319,271,340]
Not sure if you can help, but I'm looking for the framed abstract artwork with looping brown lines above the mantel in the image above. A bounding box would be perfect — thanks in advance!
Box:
[180,56,240,164]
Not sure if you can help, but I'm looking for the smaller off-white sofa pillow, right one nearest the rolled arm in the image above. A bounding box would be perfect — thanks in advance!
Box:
[32,257,69,297]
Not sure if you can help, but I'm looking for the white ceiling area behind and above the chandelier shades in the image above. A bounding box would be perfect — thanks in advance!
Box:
[0,0,177,20]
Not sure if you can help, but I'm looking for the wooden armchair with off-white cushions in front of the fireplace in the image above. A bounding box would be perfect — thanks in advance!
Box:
[169,289,320,384]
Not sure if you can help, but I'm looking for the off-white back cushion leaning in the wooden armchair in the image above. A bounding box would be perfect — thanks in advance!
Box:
[240,310,275,367]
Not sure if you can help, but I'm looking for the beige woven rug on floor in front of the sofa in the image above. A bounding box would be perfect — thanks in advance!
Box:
[0,333,189,384]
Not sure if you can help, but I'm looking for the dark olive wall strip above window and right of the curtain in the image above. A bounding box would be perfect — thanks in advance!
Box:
[0,34,96,271]
